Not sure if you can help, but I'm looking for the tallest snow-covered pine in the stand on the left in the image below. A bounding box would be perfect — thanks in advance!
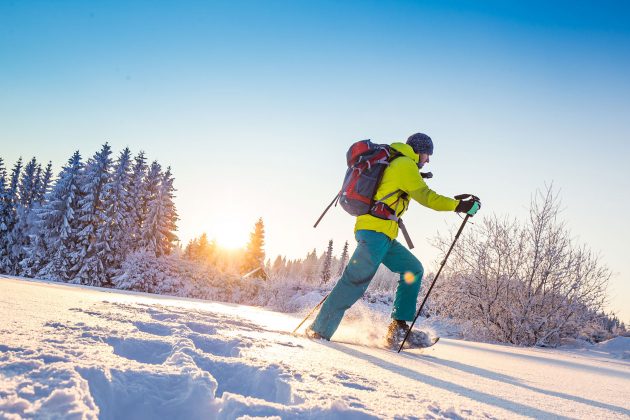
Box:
[71,143,112,286]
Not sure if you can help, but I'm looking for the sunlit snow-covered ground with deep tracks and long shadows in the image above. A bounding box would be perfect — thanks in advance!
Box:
[0,276,630,419]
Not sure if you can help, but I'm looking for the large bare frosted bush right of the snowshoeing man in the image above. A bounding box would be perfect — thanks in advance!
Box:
[432,187,611,345]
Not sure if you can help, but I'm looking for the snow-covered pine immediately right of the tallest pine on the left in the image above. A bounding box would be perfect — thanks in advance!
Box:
[95,148,132,286]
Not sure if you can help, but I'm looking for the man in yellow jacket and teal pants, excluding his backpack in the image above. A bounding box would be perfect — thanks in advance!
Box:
[306,133,480,345]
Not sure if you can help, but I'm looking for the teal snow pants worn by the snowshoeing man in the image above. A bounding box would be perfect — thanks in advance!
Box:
[310,230,424,339]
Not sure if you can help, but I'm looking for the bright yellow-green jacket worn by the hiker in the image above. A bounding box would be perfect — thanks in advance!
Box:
[354,143,459,239]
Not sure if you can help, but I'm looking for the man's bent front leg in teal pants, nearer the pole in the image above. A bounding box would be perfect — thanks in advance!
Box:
[383,241,424,321]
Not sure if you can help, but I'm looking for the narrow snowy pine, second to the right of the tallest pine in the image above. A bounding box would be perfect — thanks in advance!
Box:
[125,151,148,250]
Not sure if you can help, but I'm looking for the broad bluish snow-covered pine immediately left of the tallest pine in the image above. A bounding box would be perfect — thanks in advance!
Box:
[20,151,83,281]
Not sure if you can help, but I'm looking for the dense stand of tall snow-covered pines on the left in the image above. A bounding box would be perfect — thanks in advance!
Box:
[0,143,178,286]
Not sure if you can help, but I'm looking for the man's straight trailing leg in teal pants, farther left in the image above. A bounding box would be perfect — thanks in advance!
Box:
[309,230,392,340]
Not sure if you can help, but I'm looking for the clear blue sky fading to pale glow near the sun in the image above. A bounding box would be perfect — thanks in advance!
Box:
[0,0,630,323]
